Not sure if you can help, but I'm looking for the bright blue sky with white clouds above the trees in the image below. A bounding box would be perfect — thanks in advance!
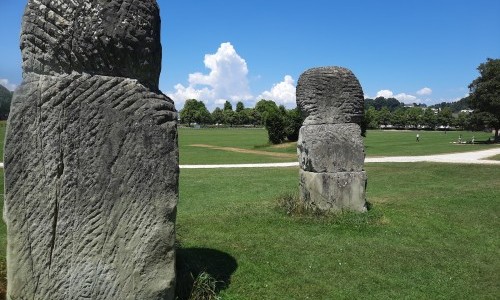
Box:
[0,0,500,110]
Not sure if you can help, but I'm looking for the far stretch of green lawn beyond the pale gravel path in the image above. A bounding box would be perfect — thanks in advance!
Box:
[179,128,498,164]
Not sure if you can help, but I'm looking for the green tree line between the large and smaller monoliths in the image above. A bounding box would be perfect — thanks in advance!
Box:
[180,99,304,144]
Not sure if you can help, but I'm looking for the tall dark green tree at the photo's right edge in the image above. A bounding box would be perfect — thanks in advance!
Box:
[469,58,500,141]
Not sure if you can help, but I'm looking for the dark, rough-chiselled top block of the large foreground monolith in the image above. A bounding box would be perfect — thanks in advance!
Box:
[21,0,161,90]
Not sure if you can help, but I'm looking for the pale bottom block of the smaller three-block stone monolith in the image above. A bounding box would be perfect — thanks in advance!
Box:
[300,170,367,212]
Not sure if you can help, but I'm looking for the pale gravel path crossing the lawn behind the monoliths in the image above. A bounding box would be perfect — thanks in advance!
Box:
[0,147,500,169]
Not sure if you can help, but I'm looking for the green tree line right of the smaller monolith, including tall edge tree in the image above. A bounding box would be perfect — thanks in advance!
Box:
[364,58,500,141]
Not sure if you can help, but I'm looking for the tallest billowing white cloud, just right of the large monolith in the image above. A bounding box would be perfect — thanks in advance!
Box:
[167,43,253,109]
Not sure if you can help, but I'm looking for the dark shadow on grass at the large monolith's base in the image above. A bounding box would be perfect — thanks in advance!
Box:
[176,248,238,300]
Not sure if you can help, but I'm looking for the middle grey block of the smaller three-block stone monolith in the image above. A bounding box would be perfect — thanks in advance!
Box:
[297,123,365,173]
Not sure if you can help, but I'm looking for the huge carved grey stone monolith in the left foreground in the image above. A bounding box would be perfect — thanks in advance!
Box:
[4,0,179,300]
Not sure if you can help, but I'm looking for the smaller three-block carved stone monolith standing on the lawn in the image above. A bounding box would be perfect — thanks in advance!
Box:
[297,67,367,212]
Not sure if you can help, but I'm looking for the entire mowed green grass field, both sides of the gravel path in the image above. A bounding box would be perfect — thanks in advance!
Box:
[0,125,500,299]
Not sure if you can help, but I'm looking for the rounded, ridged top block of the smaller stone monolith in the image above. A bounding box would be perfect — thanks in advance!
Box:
[297,67,364,125]
